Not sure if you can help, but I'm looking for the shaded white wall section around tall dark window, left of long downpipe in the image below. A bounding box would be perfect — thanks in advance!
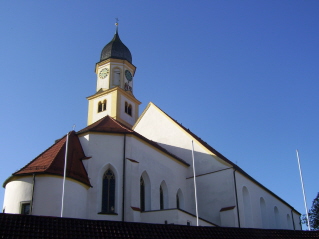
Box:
[79,134,124,220]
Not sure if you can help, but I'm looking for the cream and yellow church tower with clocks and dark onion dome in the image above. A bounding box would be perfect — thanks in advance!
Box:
[87,23,141,127]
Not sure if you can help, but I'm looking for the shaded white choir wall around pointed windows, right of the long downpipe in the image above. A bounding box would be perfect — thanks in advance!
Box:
[127,137,188,214]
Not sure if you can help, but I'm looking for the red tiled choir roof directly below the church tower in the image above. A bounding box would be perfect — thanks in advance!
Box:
[77,115,189,166]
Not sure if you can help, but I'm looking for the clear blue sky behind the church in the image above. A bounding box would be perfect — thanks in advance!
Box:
[0,0,319,228]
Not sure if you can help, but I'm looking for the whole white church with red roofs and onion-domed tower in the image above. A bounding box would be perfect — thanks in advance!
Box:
[2,23,301,230]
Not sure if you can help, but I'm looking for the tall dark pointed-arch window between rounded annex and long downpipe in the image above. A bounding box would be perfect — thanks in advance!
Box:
[102,169,115,213]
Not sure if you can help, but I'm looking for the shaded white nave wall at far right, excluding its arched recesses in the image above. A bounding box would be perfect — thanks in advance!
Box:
[236,172,301,230]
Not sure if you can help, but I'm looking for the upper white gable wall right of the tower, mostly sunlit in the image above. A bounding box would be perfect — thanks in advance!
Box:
[134,104,230,177]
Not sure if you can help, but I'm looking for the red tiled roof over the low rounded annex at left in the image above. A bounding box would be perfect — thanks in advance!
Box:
[12,131,91,186]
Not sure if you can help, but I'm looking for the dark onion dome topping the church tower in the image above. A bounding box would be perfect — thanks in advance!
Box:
[100,25,132,64]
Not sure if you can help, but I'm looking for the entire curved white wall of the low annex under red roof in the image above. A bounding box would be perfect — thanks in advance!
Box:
[4,175,87,218]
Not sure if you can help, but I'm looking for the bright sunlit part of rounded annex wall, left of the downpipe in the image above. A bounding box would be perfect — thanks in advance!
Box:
[3,176,32,213]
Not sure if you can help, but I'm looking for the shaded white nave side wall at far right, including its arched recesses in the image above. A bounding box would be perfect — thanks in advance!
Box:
[236,172,301,230]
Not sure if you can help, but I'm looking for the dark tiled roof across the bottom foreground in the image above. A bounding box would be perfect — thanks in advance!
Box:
[0,213,319,239]
